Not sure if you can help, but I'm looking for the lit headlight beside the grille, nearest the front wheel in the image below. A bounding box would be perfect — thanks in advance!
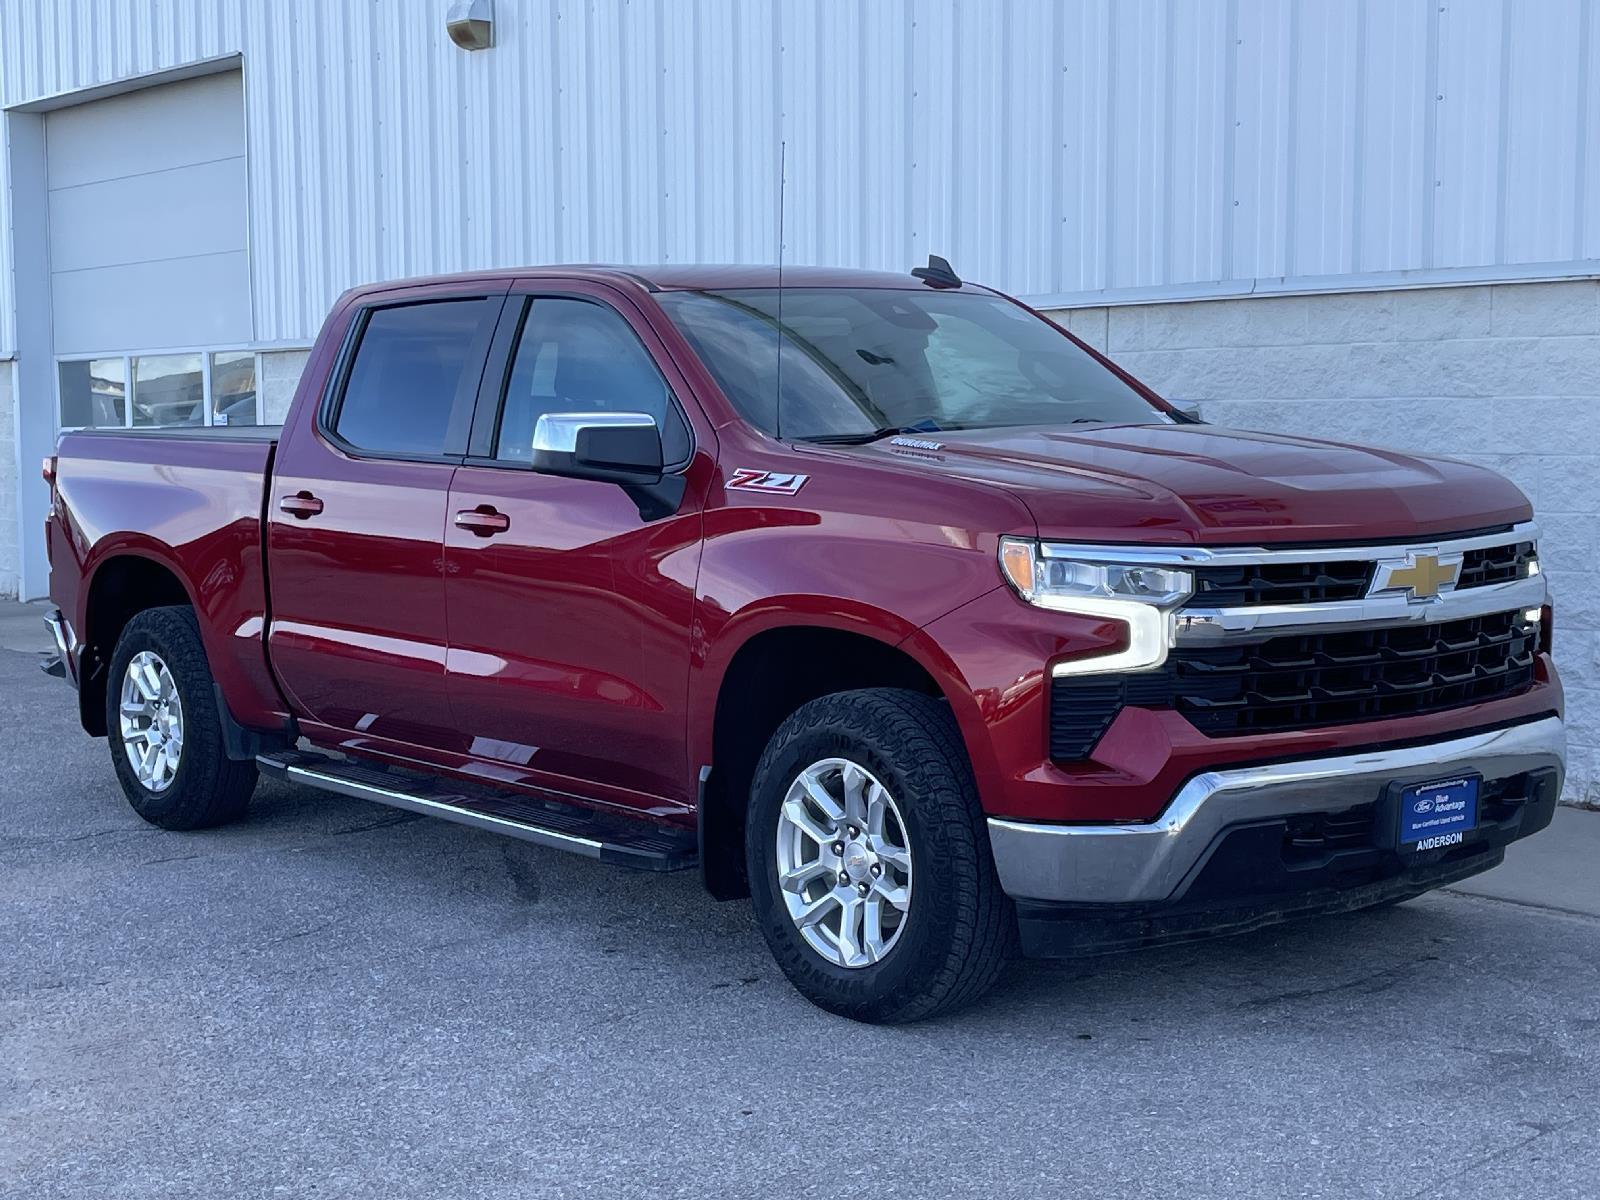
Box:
[1000,538,1194,675]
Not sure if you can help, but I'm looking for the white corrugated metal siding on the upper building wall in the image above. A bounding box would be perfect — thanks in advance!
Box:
[0,0,1600,356]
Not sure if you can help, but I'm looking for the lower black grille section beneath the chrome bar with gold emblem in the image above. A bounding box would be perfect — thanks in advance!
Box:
[1166,613,1539,736]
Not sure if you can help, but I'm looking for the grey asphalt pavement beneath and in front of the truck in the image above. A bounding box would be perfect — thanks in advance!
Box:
[0,651,1600,1200]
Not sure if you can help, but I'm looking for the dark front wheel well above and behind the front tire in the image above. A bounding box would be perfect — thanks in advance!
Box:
[698,624,949,899]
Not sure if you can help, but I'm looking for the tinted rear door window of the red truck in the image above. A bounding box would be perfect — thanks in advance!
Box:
[333,299,501,454]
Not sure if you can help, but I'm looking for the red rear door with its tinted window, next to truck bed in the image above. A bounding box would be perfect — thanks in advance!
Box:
[267,283,506,747]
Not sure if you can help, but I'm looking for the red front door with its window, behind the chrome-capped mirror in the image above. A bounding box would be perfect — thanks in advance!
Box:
[445,290,710,813]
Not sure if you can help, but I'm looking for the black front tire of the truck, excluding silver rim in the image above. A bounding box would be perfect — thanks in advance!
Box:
[746,688,1016,1024]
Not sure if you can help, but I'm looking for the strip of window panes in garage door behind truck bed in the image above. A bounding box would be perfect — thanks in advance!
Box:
[58,350,261,429]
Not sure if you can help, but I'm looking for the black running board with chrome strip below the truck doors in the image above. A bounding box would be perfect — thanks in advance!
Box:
[256,750,699,870]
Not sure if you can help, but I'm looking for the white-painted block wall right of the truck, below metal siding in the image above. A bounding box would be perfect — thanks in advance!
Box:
[1053,280,1600,806]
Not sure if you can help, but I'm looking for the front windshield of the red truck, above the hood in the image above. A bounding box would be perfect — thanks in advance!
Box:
[656,288,1171,440]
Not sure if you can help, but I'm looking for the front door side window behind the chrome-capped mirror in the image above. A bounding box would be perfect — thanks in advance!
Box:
[494,298,690,464]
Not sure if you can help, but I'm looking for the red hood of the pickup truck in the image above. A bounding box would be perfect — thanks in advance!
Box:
[862,426,1533,544]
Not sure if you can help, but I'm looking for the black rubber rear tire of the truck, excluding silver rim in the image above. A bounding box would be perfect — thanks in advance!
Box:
[106,608,256,829]
